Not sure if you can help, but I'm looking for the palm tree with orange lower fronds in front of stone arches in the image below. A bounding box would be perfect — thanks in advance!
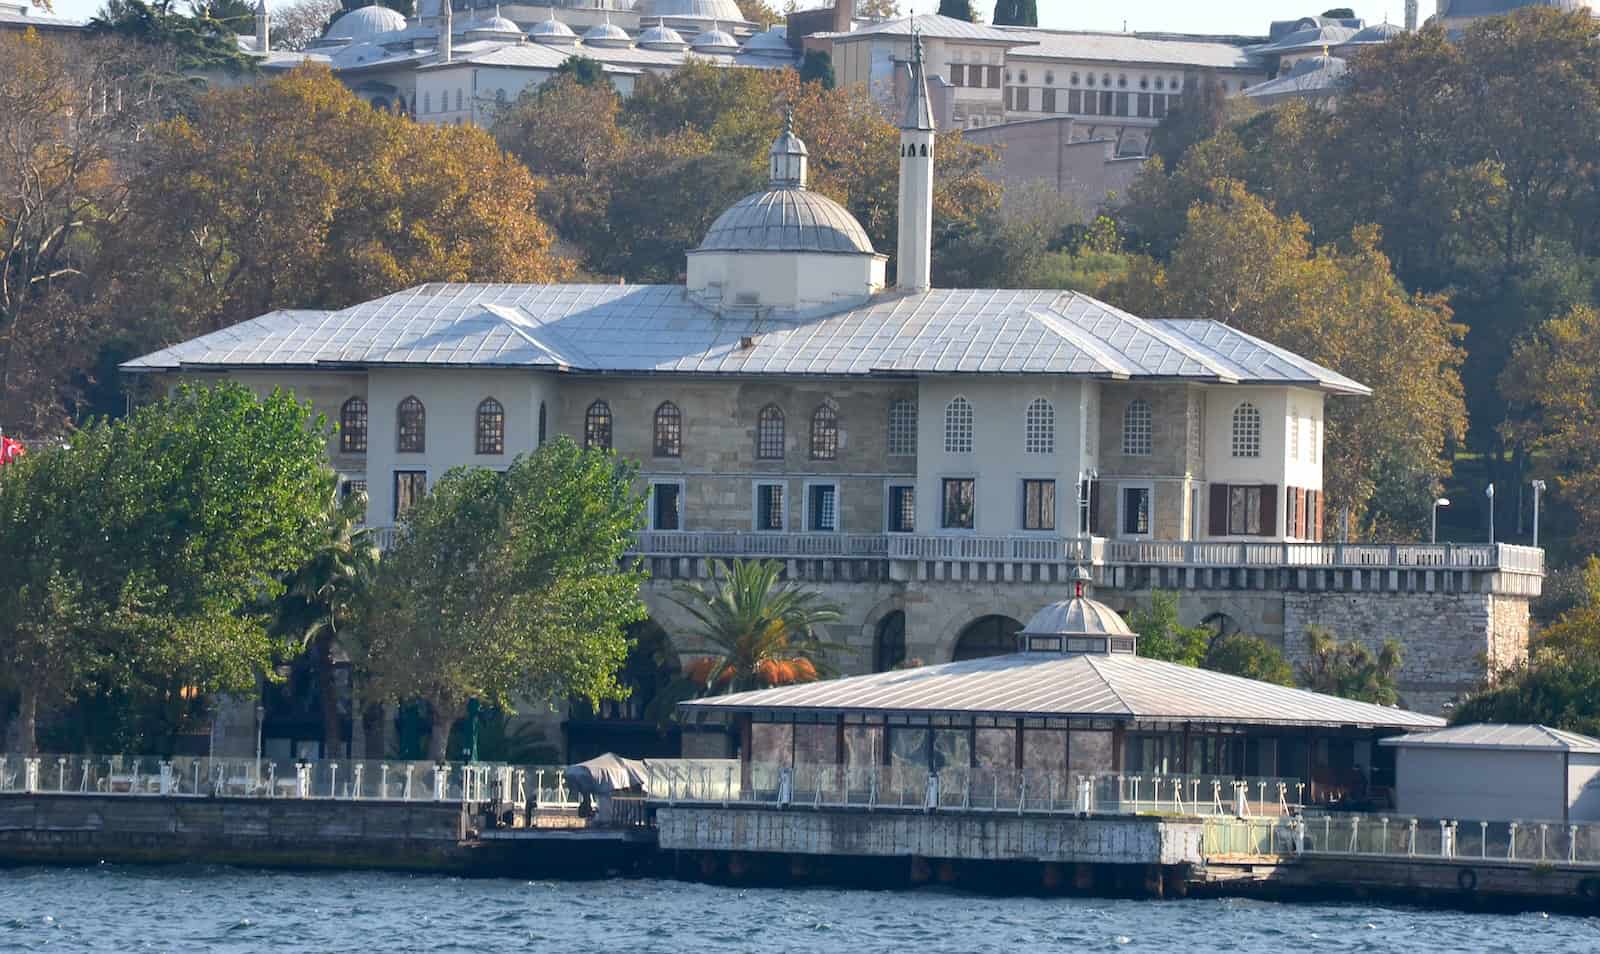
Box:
[672,560,848,695]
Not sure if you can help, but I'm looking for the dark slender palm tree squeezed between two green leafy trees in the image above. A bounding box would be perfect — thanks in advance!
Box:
[275,483,379,754]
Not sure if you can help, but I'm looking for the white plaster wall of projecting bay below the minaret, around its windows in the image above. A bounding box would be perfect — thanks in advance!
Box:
[917,375,1099,536]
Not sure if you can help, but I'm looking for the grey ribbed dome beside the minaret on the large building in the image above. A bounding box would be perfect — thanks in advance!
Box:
[698,189,874,255]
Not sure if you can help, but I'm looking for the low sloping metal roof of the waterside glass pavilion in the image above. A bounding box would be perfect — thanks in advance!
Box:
[678,653,1443,728]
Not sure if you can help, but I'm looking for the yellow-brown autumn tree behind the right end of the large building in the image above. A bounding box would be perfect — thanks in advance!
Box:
[1107,179,1466,535]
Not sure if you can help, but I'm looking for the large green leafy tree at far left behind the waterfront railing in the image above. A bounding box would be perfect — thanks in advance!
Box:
[0,384,328,751]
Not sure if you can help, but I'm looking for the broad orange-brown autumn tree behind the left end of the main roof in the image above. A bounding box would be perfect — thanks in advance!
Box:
[101,67,566,348]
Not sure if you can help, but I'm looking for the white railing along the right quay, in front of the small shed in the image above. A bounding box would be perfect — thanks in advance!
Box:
[1203,813,1600,866]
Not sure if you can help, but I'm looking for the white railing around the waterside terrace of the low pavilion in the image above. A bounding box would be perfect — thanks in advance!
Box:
[648,760,1304,818]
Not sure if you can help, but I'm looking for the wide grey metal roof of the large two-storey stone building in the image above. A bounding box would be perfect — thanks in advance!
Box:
[123,285,1370,394]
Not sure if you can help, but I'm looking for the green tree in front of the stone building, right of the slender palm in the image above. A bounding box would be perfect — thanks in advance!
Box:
[363,437,645,759]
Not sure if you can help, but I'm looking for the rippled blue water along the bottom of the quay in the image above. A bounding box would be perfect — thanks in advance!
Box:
[0,866,1600,954]
